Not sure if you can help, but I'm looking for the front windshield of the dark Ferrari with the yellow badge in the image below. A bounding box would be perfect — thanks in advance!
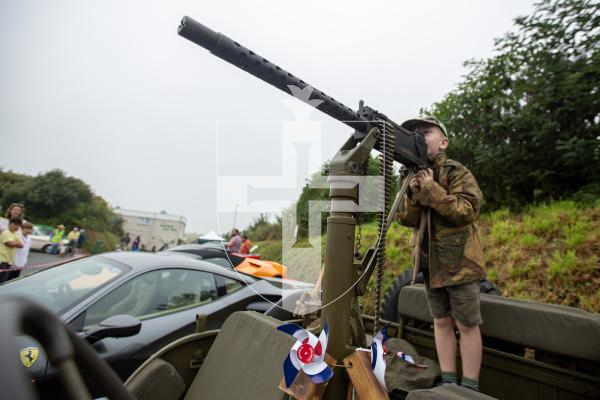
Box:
[0,257,129,313]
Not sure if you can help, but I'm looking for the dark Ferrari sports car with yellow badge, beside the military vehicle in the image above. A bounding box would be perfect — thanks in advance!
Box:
[0,252,312,398]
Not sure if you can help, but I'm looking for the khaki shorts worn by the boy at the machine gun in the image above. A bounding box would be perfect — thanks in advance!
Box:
[425,278,483,326]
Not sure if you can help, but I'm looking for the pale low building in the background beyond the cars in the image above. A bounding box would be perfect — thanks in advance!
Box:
[114,208,186,251]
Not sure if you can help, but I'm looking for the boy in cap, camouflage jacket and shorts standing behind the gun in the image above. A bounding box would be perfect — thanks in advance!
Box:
[399,117,485,391]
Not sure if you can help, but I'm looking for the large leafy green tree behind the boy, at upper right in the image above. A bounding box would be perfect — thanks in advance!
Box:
[423,0,600,208]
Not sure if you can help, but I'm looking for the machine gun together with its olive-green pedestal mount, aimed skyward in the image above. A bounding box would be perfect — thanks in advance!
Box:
[178,17,428,399]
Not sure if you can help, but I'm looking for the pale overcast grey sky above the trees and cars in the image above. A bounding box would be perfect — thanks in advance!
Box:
[0,0,533,232]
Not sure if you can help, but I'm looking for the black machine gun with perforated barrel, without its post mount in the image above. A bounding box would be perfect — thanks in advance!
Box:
[177,16,427,168]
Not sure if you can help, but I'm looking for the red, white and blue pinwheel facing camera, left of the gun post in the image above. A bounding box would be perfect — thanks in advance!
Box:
[277,322,333,388]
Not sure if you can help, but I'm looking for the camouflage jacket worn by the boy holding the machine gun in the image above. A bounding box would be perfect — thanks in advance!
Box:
[399,153,485,288]
